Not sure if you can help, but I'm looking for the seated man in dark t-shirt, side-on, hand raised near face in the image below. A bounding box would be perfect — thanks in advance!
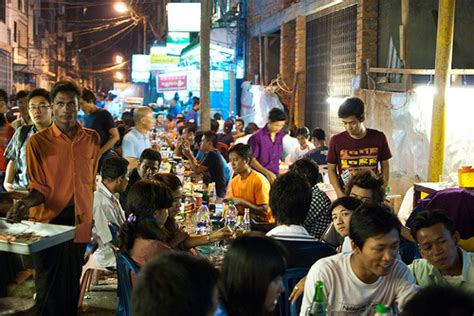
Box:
[182,131,227,198]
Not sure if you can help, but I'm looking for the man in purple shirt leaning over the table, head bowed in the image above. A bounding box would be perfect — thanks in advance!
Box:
[248,108,286,183]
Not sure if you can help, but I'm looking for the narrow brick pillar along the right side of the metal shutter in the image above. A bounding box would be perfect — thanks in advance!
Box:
[356,0,378,88]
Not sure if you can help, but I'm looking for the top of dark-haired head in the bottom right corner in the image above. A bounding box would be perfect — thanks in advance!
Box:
[401,285,474,316]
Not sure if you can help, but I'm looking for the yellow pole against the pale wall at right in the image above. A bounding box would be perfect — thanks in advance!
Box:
[428,0,456,182]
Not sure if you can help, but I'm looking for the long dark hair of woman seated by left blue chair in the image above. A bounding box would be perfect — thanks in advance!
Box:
[118,180,173,254]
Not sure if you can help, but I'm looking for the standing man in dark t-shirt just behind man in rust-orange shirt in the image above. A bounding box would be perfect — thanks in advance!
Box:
[80,89,120,172]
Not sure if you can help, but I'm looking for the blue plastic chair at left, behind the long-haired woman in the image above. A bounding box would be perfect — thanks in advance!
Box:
[115,252,139,316]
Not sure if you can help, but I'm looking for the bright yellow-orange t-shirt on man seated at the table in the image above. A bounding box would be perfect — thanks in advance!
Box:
[229,170,272,221]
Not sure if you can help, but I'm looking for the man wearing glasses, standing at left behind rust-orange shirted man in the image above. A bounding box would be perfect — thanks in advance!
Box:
[3,89,52,196]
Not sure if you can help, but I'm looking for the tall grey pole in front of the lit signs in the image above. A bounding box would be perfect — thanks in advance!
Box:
[199,0,211,131]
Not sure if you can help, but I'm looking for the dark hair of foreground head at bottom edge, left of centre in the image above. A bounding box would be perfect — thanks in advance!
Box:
[132,252,218,316]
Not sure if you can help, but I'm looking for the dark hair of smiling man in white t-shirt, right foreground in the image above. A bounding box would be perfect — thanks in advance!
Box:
[349,203,401,250]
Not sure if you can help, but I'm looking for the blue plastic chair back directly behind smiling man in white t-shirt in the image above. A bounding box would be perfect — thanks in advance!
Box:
[278,268,309,316]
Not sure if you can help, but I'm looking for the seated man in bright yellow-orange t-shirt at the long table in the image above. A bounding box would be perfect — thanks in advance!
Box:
[229,144,271,221]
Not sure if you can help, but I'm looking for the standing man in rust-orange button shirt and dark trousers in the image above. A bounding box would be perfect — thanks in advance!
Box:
[8,81,100,315]
